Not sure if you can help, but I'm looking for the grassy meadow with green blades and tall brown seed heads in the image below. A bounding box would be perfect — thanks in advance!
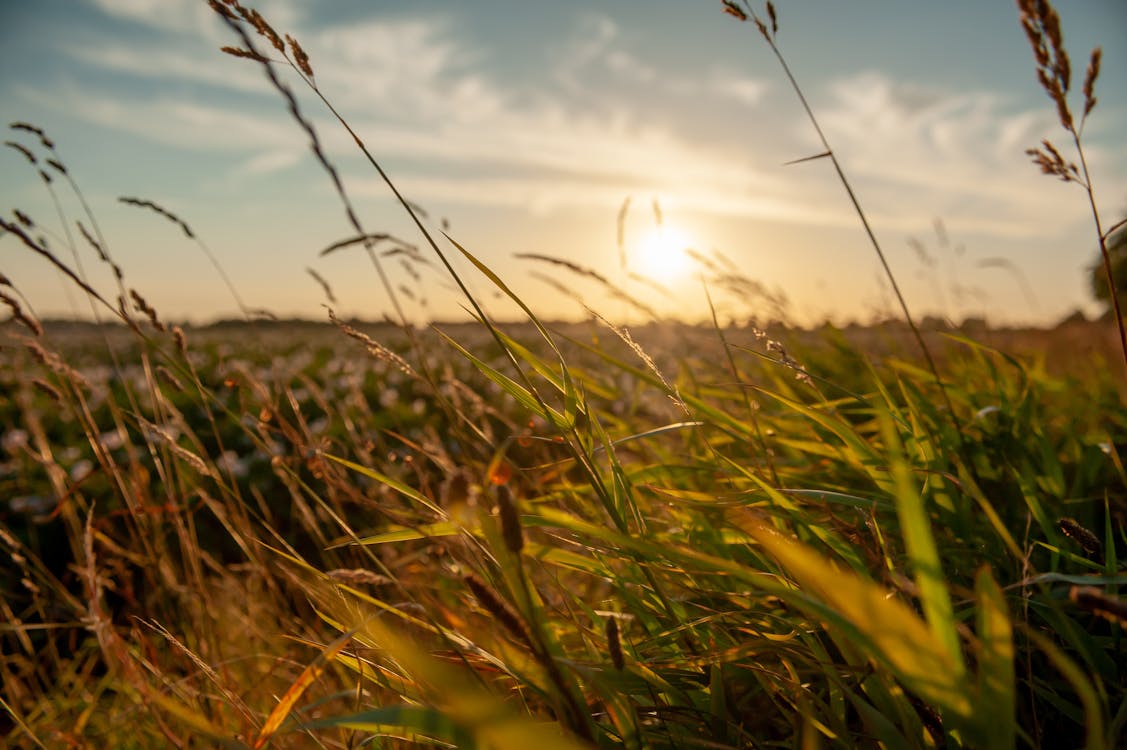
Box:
[0,0,1127,750]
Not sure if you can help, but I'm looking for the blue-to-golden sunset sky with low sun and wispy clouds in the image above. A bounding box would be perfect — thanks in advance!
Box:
[0,0,1127,325]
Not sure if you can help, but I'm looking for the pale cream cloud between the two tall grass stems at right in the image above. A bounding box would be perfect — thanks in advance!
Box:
[804,72,1127,237]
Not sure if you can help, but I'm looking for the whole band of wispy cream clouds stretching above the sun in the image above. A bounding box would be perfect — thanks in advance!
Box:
[46,0,1117,237]
